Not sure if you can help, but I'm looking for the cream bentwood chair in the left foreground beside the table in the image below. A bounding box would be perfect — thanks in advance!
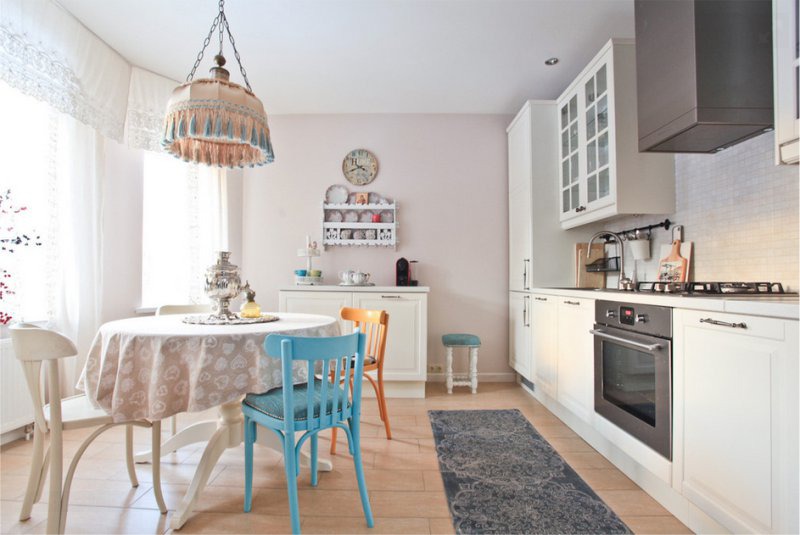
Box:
[11,323,167,533]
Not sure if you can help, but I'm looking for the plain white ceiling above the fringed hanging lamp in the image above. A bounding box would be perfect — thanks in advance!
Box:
[58,0,634,114]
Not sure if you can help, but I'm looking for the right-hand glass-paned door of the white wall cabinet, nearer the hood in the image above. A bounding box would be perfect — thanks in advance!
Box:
[584,65,611,204]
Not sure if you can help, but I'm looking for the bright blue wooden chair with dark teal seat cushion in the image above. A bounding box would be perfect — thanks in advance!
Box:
[242,330,374,533]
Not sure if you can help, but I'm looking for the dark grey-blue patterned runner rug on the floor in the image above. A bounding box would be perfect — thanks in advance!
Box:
[428,410,631,533]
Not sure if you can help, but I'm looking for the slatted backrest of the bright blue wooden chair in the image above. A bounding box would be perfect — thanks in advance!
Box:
[264,331,366,433]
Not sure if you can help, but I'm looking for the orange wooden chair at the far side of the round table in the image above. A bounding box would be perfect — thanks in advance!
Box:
[331,307,392,455]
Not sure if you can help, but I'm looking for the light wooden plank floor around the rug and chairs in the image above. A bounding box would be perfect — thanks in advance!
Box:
[0,383,690,533]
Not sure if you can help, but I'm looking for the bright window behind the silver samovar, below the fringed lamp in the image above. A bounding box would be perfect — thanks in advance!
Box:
[142,151,220,307]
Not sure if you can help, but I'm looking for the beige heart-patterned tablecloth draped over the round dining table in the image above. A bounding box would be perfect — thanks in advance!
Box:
[78,313,340,422]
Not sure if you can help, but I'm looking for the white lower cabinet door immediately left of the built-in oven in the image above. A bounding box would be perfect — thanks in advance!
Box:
[554,297,594,422]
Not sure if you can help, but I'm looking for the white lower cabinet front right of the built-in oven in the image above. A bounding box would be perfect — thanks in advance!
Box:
[673,309,800,533]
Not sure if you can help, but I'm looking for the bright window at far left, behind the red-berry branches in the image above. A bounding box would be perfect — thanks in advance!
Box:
[0,81,58,324]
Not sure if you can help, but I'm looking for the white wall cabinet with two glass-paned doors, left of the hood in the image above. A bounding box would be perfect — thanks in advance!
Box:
[556,39,675,229]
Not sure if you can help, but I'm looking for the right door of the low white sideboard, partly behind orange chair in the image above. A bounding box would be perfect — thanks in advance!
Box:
[353,293,428,381]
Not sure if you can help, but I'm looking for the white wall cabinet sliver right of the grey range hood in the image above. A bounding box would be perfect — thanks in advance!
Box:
[772,0,800,164]
